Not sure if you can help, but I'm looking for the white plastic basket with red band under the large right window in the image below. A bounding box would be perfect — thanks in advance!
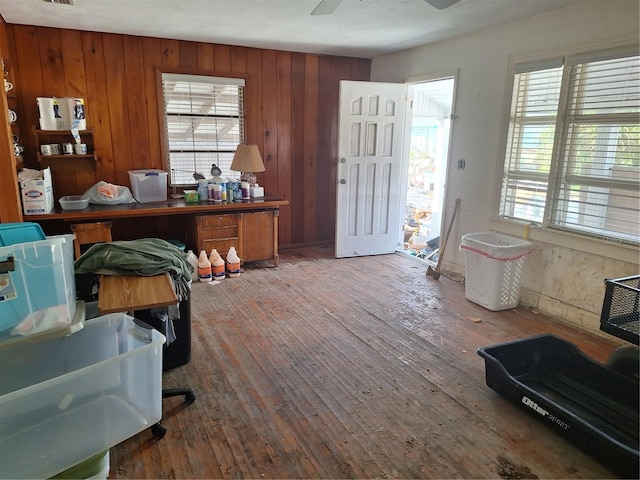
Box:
[460,232,533,311]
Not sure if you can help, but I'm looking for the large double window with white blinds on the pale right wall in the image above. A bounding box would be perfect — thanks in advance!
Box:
[499,47,640,243]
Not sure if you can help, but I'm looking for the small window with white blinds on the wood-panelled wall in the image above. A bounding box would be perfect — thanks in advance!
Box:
[162,73,245,186]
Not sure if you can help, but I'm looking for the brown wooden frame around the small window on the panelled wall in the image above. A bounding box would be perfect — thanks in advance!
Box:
[155,67,248,189]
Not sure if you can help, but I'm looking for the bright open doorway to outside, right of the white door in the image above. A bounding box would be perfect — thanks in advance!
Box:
[400,77,455,262]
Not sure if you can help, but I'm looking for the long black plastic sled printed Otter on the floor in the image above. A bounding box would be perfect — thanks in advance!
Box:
[478,334,640,478]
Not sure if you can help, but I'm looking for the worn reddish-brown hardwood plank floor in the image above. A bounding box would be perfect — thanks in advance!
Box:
[110,247,623,479]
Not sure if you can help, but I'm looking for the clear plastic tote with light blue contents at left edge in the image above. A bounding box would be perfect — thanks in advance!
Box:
[0,235,76,342]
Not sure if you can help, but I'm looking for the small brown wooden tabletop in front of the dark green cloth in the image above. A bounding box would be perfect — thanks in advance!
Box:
[98,273,178,314]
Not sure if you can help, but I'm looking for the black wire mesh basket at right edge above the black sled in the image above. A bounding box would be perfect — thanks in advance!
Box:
[600,275,640,345]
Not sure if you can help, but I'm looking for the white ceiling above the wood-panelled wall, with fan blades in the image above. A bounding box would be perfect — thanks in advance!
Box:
[0,0,585,58]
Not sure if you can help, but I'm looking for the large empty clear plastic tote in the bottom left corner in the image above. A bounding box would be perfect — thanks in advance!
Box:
[0,313,165,478]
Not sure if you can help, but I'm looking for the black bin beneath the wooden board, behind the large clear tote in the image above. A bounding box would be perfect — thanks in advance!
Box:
[134,295,191,371]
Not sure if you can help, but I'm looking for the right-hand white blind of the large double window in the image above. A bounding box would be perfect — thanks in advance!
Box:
[551,57,640,242]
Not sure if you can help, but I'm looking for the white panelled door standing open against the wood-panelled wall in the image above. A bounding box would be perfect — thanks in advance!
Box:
[335,81,406,257]
